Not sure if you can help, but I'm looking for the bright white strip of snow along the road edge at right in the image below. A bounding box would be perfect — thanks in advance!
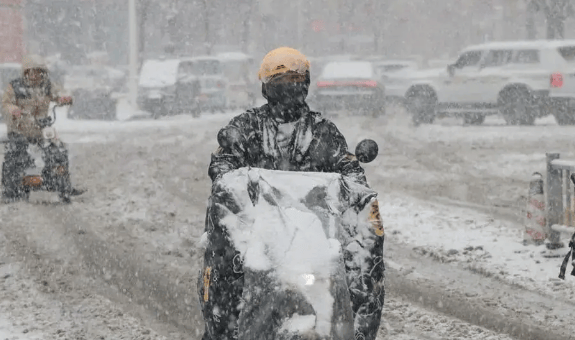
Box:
[380,196,575,300]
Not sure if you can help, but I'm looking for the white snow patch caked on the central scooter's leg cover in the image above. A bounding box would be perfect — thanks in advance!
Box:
[216,168,363,335]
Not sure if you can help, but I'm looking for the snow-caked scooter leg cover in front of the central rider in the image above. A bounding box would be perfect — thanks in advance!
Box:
[198,168,384,340]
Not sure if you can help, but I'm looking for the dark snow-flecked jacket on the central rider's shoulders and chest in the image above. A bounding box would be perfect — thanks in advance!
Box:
[209,104,366,184]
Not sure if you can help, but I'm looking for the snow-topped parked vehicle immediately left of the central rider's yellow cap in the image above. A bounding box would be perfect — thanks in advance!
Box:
[217,52,260,109]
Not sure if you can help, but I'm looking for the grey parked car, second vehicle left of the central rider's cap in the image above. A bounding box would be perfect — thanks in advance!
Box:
[189,56,227,113]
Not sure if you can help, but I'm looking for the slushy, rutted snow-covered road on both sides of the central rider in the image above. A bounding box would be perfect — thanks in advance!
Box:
[0,105,575,339]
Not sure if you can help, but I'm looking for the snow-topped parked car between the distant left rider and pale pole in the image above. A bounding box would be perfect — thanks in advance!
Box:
[63,65,126,120]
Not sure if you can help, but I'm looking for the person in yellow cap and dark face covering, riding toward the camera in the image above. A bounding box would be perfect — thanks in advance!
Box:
[198,47,385,340]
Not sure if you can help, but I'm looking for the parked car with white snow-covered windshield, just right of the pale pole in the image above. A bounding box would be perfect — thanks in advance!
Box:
[138,59,201,118]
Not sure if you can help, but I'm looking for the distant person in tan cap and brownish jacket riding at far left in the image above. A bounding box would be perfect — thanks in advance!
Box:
[2,55,83,203]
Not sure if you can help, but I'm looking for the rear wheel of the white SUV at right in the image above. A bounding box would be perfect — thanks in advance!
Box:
[500,88,535,125]
